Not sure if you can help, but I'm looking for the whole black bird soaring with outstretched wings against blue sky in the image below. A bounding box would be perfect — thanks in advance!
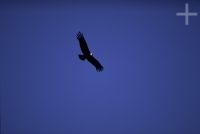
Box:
[76,32,104,72]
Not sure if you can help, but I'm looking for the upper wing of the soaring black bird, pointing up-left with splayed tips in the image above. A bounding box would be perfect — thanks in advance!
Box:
[77,32,90,55]
